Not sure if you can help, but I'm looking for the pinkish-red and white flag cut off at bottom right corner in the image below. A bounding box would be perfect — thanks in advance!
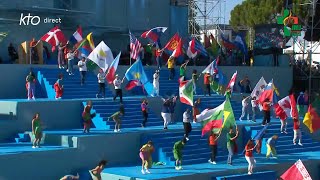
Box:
[280,159,312,180]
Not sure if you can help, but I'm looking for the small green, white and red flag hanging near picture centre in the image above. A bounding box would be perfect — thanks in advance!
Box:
[179,80,193,106]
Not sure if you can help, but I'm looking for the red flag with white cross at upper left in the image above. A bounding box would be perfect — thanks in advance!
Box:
[41,26,66,51]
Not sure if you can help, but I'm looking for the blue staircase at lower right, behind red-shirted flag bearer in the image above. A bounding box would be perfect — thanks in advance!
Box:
[246,119,320,154]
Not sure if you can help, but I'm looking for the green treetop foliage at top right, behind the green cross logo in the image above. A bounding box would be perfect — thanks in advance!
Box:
[229,0,308,30]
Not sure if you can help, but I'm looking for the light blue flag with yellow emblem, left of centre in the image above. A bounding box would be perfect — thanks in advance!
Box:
[125,58,153,95]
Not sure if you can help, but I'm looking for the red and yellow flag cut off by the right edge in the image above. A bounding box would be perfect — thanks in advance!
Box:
[303,97,320,133]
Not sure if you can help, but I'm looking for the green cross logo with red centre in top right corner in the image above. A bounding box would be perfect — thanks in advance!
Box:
[277,9,302,37]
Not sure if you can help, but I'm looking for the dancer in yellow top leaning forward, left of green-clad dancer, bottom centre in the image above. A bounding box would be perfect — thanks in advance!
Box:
[139,141,154,174]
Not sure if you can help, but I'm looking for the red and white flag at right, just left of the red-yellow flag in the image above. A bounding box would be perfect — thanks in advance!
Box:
[274,94,299,120]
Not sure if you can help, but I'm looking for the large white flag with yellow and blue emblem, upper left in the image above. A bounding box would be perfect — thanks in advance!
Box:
[88,41,113,72]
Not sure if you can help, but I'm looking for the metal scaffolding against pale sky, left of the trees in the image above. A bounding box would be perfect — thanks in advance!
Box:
[188,0,226,37]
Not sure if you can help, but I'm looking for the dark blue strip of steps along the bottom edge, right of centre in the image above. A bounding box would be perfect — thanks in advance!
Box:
[211,171,277,180]
